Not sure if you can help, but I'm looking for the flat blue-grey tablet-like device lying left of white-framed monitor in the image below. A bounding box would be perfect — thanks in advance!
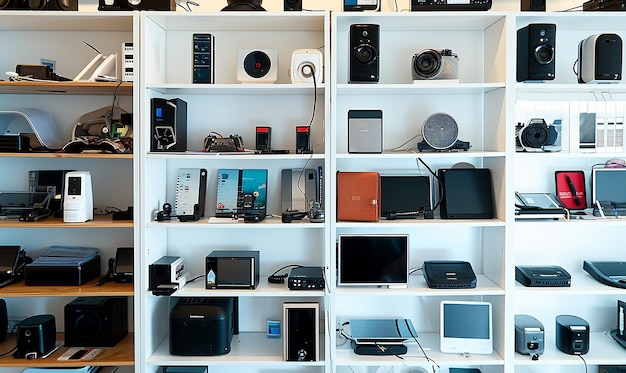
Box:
[350,318,417,344]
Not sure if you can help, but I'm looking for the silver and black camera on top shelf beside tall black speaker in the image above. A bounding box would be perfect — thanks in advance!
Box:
[411,49,459,80]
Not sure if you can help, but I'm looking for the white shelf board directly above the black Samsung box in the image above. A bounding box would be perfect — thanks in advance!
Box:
[171,280,324,297]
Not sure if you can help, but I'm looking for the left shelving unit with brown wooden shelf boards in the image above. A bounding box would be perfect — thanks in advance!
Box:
[0,11,138,372]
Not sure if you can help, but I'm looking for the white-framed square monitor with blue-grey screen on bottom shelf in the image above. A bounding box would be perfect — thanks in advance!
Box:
[440,301,493,354]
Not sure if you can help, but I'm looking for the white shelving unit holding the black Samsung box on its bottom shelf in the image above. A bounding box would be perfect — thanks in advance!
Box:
[139,11,331,372]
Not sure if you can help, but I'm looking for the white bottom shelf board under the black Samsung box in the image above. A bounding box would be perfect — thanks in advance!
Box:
[146,333,325,364]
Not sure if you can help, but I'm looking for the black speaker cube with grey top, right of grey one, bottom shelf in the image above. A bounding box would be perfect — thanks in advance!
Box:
[556,315,589,355]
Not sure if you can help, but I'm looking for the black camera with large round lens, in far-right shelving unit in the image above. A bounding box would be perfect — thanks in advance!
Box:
[515,118,561,152]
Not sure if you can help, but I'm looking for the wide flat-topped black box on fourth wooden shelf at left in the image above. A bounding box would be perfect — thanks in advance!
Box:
[24,246,100,286]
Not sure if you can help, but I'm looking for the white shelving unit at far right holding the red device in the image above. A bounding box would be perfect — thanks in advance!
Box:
[506,12,626,373]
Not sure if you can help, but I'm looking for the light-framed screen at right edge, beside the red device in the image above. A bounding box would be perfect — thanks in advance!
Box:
[591,168,626,204]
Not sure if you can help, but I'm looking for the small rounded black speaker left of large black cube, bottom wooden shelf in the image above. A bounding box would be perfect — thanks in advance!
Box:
[13,315,57,358]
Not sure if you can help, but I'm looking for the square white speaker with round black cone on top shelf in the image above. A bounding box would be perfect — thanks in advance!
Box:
[237,49,278,83]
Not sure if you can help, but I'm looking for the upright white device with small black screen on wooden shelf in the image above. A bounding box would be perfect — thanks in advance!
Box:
[63,171,93,223]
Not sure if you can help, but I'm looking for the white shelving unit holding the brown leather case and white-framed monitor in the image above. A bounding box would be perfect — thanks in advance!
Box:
[330,12,513,372]
